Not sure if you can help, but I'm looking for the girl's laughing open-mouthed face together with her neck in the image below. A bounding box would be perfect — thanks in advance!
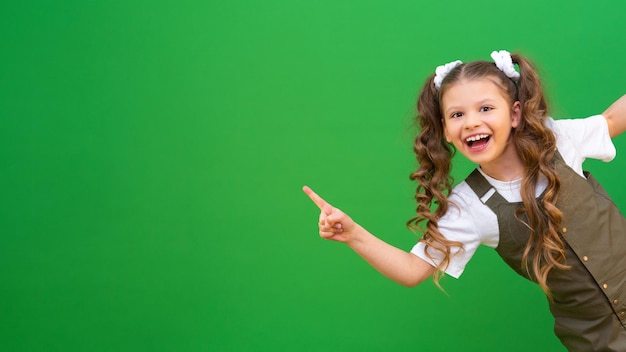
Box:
[441,78,523,180]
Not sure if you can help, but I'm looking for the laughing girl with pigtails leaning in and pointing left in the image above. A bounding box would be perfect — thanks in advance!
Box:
[304,51,626,351]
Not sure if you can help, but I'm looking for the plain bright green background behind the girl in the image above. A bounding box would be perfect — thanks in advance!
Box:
[0,0,626,351]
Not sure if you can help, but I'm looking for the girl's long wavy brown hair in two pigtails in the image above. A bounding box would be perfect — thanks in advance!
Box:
[407,54,568,297]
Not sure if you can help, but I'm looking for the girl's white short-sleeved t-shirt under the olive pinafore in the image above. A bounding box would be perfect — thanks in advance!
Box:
[411,115,615,278]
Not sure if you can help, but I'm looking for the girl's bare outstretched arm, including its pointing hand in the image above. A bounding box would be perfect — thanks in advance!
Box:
[303,186,434,287]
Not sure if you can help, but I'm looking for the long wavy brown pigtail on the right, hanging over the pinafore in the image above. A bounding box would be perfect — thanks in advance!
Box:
[511,55,568,297]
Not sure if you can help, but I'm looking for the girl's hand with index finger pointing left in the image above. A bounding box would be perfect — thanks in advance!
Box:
[302,186,356,243]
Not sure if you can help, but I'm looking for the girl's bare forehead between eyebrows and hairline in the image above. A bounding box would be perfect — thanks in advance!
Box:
[441,77,509,109]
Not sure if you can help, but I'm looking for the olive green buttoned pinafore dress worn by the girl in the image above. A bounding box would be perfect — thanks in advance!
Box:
[465,152,626,352]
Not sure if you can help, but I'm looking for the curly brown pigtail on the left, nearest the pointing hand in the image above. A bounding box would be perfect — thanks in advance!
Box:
[407,75,461,286]
